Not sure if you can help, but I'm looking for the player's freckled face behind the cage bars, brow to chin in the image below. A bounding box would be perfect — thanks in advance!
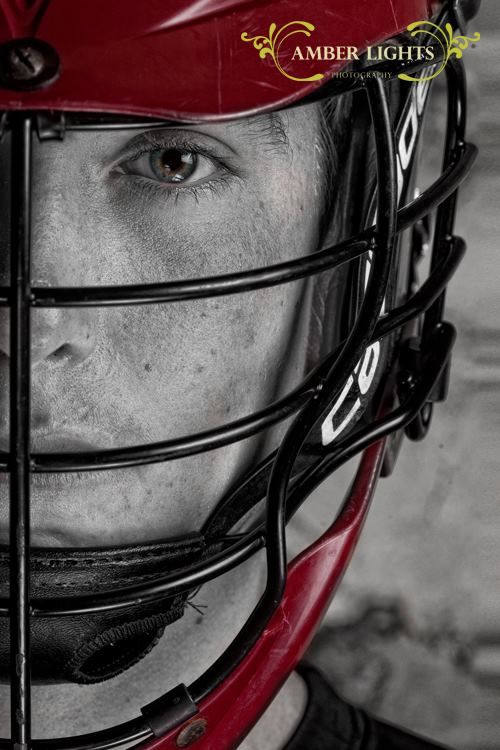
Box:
[0,107,324,546]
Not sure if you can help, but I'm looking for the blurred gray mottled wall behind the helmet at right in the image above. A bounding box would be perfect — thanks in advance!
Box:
[300,7,500,750]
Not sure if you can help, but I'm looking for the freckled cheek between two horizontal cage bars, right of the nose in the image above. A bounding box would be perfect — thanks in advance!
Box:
[102,285,299,440]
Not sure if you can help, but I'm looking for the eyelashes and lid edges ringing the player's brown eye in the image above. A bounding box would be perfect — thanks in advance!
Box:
[113,133,241,203]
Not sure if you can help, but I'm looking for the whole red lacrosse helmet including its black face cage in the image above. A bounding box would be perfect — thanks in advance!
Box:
[0,0,476,750]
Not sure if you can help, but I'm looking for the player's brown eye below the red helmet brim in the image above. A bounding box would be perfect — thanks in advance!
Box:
[113,131,237,194]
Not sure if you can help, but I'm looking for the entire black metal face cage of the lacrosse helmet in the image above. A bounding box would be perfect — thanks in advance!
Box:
[0,16,476,750]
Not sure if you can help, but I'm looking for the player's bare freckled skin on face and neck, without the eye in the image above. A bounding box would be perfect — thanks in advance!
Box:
[0,107,323,750]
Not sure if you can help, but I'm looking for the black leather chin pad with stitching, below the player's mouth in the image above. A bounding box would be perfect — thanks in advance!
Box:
[0,536,204,684]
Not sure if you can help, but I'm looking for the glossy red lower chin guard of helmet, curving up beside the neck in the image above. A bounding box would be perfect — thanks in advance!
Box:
[141,442,384,750]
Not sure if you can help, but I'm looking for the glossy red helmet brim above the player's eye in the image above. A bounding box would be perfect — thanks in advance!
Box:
[0,0,435,119]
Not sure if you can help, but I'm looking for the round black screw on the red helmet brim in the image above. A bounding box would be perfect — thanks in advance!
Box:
[0,39,59,91]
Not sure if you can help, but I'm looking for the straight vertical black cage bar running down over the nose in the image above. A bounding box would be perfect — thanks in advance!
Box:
[9,115,31,750]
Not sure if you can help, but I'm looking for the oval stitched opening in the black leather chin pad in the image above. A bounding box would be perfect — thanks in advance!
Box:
[65,623,164,685]
